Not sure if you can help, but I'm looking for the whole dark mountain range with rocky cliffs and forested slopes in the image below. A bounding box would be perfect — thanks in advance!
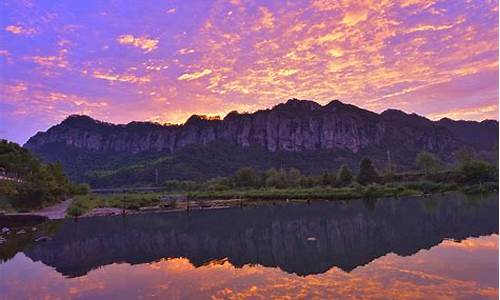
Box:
[24,99,498,187]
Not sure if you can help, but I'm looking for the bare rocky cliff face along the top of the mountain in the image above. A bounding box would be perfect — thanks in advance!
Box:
[25,100,480,153]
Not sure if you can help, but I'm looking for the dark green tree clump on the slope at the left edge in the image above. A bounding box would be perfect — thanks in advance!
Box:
[0,140,88,209]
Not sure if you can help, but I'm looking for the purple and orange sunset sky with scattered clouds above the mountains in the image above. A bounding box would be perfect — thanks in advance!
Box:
[0,0,499,143]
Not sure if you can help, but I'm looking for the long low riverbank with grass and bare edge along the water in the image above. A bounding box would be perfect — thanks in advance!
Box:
[67,182,498,217]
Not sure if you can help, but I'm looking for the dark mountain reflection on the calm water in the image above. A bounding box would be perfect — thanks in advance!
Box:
[24,194,498,277]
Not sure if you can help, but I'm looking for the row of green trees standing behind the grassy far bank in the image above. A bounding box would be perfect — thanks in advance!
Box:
[165,148,498,191]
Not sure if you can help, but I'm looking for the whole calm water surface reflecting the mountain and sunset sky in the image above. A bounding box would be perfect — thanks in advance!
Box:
[0,195,498,299]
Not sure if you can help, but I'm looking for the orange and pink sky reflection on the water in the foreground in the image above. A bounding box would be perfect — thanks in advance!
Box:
[0,235,498,299]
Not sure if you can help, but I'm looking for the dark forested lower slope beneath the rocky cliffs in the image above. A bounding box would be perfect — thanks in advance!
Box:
[35,141,496,188]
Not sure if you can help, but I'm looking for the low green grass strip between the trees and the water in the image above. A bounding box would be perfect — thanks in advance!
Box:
[68,181,498,216]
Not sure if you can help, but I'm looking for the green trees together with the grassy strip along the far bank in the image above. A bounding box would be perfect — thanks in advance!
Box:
[64,151,498,216]
